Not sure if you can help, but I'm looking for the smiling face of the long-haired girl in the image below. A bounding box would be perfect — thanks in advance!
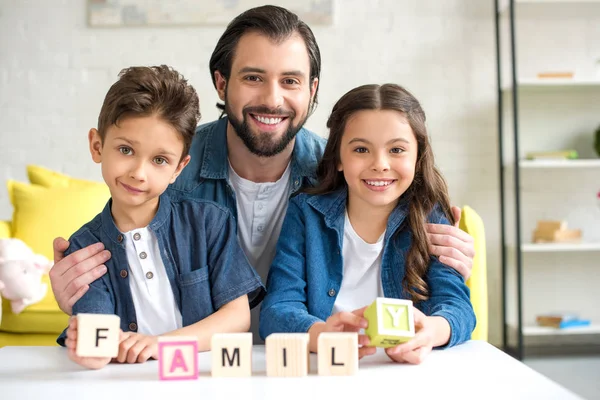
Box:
[338,110,418,214]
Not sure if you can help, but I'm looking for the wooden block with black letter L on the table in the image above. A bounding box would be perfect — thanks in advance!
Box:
[317,332,358,376]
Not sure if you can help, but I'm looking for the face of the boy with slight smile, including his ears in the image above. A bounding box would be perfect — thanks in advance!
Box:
[89,115,190,212]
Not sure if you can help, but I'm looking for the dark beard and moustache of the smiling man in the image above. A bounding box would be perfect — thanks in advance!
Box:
[225,99,308,157]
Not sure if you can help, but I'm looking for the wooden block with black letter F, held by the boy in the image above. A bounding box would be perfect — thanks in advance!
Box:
[75,313,121,357]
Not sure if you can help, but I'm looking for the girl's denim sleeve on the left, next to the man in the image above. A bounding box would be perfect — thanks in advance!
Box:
[259,197,323,339]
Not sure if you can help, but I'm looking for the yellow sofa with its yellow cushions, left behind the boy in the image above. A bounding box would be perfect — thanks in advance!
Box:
[0,165,110,347]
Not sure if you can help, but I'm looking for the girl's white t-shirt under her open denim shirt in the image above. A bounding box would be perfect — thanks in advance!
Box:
[332,211,385,314]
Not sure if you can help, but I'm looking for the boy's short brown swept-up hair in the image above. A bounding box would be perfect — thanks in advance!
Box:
[98,65,200,159]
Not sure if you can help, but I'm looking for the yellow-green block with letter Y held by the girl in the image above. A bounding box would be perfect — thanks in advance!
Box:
[365,297,415,347]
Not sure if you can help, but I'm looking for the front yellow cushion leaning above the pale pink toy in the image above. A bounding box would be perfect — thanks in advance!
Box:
[8,180,110,260]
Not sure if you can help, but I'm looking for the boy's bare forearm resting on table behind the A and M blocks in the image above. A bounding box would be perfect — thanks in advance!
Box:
[160,295,250,351]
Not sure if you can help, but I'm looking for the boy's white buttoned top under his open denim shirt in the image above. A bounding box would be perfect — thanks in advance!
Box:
[124,227,182,335]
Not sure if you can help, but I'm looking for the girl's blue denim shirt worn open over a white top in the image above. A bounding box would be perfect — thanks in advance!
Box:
[260,188,475,347]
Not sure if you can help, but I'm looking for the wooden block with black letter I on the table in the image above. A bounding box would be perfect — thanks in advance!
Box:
[265,333,309,376]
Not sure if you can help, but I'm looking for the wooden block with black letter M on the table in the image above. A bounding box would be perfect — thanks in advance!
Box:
[210,332,252,377]
